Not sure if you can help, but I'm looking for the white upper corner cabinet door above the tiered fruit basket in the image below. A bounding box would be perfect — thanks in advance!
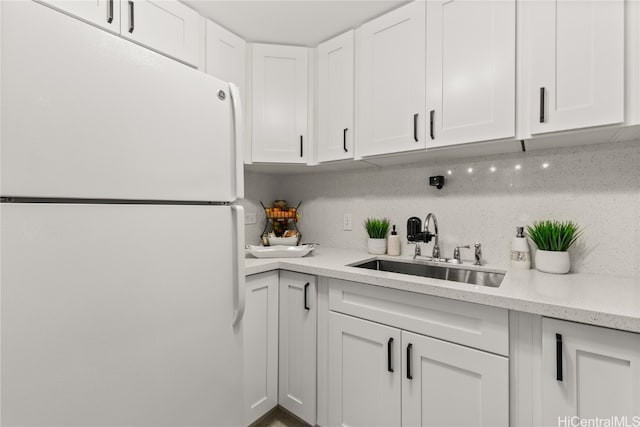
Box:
[251,44,308,163]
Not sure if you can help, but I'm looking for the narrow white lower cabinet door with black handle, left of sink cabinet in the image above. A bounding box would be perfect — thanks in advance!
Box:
[278,271,318,425]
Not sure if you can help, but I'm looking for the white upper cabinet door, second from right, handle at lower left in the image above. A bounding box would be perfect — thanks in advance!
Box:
[426,0,516,147]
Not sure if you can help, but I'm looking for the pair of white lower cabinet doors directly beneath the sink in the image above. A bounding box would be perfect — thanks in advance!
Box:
[328,312,509,426]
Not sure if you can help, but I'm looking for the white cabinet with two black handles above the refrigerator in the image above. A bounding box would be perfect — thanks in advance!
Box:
[38,0,203,67]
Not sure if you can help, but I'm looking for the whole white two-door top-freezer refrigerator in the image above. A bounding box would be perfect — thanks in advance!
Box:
[0,1,244,426]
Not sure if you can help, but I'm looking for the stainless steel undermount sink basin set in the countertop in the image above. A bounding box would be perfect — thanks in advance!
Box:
[351,259,505,288]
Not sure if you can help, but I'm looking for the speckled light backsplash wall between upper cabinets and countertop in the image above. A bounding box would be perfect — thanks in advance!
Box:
[246,141,640,277]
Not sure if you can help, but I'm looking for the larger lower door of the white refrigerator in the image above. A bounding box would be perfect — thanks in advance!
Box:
[0,203,244,426]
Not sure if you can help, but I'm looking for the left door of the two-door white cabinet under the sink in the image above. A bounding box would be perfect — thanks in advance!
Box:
[329,312,402,426]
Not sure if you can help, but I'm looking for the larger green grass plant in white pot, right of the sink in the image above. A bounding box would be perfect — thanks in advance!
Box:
[527,220,582,274]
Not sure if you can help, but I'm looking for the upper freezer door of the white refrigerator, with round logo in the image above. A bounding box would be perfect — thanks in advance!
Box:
[0,1,242,201]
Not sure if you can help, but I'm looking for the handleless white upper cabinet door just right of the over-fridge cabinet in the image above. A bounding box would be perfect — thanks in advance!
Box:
[205,20,247,91]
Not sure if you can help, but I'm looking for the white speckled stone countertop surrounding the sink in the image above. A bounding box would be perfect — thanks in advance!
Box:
[245,247,640,333]
